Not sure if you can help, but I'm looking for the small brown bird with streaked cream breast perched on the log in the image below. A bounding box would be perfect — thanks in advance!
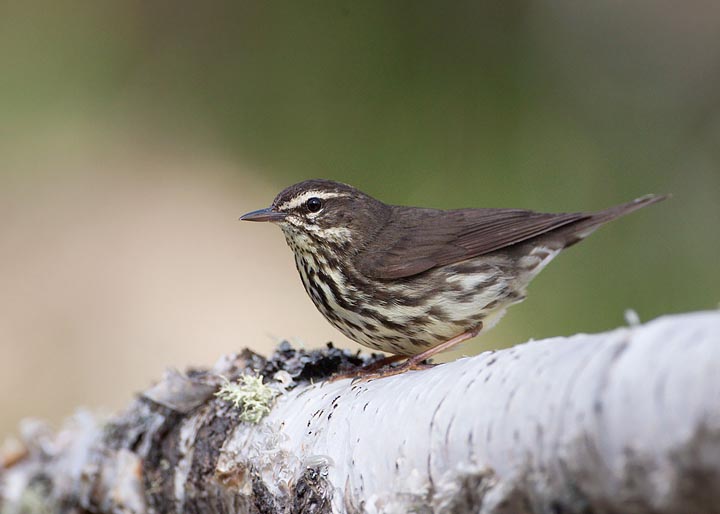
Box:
[240,179,667,376]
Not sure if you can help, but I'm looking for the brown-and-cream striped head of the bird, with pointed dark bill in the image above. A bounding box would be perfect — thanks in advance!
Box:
[240,179,389,249]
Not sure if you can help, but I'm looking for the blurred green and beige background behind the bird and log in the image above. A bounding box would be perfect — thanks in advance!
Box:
[0,0,720,438]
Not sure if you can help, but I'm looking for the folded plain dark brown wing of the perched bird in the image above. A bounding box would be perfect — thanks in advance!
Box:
[356,207,590,279]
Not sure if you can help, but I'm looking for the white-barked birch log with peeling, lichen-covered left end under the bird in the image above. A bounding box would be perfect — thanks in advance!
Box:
[0,312,720,514]
